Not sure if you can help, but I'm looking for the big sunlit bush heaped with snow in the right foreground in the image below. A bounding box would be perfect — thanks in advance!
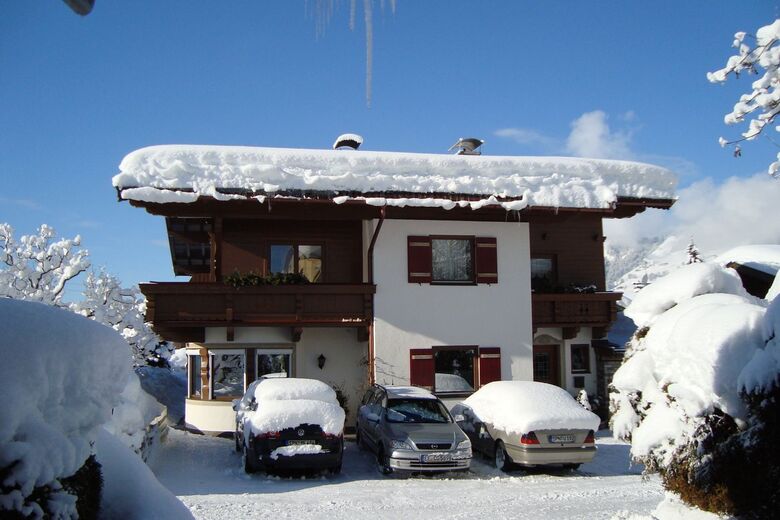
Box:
[610,263,780,517]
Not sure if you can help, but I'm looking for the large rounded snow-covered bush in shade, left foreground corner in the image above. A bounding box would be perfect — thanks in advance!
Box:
[0,298,130,518]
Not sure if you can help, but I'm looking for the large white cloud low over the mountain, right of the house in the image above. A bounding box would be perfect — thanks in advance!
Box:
[604,173,780,256]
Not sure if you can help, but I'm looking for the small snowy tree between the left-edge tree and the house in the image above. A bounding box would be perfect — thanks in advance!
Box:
[72,270,172,366]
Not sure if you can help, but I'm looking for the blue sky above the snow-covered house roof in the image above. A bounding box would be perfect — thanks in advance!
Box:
[0,0,778,294]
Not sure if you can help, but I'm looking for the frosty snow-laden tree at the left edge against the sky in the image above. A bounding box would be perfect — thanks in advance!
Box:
[0,223,89,306]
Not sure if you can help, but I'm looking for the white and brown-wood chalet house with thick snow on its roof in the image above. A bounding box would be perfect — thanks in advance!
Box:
[113,141,676,433]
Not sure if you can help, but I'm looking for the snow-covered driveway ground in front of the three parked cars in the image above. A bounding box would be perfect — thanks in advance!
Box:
[152,430,663,520]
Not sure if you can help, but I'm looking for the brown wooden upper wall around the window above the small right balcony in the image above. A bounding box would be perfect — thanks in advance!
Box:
[529,213,606,291]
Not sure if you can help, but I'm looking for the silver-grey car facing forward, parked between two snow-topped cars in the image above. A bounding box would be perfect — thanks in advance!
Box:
[356,385,471,475]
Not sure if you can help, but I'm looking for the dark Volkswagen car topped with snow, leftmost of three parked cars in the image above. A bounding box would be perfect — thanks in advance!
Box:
[233,377,345,474]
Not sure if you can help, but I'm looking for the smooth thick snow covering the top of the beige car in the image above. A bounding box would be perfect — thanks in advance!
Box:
[464,381,600,435]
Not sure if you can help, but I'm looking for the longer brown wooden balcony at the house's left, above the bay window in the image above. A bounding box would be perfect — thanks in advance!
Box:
[141,282,376,341]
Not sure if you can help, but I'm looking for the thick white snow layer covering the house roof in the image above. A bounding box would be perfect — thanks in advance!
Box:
[113,145,677,210]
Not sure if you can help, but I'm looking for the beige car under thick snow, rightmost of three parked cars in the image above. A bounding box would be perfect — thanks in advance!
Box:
[452,381,600,471]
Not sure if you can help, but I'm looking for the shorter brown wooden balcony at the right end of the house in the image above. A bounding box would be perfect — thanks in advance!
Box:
[531,292,623,329]
